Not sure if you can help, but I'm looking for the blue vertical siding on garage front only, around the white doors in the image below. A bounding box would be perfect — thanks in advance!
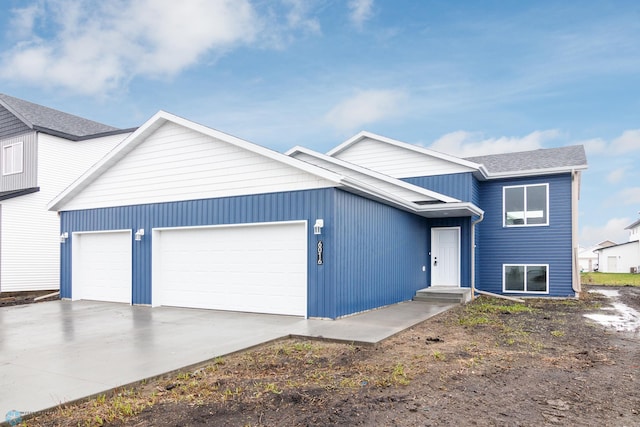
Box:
[60,188,336,317]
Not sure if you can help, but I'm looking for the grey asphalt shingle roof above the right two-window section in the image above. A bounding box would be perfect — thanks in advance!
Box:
[465,145,587,173]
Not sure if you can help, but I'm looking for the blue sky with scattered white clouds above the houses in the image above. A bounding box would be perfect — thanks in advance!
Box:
[0,0,640,247]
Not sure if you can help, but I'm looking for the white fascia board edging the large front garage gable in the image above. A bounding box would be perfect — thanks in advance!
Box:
[47,110,342,211]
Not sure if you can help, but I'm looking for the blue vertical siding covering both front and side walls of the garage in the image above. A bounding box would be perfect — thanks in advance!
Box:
[61,188,436,318]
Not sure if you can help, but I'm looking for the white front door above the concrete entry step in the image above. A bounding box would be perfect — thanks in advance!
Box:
[431,227,460,286]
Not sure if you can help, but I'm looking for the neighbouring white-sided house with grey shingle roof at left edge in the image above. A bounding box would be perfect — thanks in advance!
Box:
[0,94,132,292]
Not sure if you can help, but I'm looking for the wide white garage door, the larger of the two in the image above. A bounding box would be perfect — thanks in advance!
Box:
[153,222,307,316]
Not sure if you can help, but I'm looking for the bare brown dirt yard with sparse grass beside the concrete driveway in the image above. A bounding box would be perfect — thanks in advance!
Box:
[26,286,640,426]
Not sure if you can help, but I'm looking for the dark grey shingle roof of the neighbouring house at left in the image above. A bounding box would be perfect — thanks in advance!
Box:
[0,93,125,140]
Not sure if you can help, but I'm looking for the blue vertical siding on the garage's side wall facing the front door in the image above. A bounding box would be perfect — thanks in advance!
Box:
[325,191,427,317]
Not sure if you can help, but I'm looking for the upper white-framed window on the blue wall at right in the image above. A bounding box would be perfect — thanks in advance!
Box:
[503,184,549,227]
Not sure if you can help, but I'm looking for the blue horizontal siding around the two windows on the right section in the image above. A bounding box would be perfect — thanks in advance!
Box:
[476,174,575,297]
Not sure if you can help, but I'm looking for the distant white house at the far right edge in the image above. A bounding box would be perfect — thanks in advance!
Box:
[596,220,640,273]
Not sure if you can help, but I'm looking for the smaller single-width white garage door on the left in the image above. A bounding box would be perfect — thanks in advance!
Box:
[71,230,131,304]
